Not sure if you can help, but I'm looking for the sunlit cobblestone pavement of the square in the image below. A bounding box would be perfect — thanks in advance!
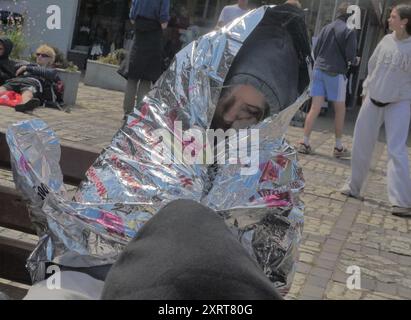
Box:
[0,85,411,300]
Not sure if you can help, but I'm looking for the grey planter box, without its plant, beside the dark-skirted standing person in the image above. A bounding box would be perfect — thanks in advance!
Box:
[84,60,127,92]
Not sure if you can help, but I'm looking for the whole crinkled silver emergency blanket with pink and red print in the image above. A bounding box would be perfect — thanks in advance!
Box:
[7,7,308,292]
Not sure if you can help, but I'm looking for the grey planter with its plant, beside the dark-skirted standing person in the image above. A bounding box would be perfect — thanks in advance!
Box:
[84,49,127,91]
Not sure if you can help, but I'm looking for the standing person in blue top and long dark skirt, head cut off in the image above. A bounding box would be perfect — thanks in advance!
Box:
[123,0,170,116]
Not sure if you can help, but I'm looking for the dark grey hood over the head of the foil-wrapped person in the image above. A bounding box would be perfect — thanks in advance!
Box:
[225,5,311,115]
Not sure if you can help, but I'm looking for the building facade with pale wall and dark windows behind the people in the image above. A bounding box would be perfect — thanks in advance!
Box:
[0,0,396,106]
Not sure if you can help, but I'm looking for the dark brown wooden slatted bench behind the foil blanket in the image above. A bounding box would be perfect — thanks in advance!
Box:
[0,132,99,299]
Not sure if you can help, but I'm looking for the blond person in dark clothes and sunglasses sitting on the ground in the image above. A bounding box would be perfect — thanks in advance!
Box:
[0,45,62,112]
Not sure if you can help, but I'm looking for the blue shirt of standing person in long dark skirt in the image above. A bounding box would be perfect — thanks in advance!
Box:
[130,0,170,23]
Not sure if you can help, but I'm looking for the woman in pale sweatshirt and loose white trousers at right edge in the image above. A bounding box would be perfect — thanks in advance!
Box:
[341,4,411,217]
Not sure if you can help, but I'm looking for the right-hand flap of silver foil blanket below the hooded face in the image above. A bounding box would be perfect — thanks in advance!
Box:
[202,93,308,294]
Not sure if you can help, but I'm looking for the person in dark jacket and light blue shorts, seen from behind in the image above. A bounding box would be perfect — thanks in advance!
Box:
[298,2,357,158]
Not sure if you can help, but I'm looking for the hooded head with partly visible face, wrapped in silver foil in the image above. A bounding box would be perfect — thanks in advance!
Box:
[212,5,310,130]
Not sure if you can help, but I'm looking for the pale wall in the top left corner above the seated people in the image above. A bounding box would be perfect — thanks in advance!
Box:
[0,0,79,53]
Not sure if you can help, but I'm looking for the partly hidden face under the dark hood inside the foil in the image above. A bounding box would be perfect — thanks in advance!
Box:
[212,85,266,130]
